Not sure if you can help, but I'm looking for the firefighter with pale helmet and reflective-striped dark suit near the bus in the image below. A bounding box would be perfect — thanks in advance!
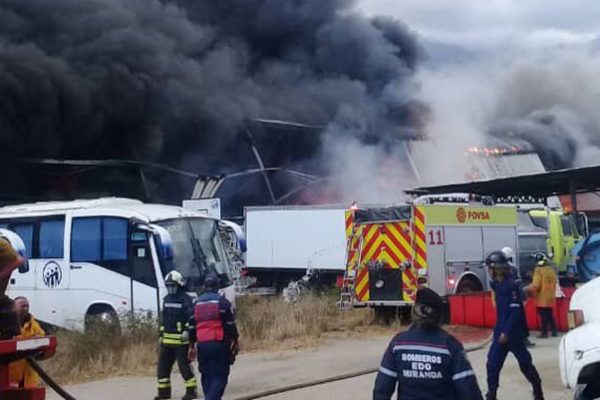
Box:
[155,271,198,400]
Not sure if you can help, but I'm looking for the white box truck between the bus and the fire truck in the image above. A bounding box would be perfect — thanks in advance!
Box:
[244,205,347,291]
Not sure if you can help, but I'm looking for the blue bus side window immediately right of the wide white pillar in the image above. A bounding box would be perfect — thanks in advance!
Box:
[71,218,102,262]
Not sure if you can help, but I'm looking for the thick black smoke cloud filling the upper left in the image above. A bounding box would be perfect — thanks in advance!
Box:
[0,0,420,179]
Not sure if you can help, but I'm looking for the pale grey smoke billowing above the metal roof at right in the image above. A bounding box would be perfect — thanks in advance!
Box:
[417,47,600,183]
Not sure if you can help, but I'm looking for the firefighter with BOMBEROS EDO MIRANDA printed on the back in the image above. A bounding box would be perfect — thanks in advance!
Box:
[373,288,482,400]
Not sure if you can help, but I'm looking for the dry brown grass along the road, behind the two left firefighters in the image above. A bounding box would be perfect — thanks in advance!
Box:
[44,292,390,383]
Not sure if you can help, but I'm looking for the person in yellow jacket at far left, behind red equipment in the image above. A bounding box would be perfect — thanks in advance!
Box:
[9,296,46,388]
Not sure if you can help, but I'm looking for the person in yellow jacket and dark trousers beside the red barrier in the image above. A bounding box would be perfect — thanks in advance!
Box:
[530,254,558,339]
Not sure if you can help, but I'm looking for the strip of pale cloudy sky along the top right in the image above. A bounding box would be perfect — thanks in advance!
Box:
[358,0,600,50]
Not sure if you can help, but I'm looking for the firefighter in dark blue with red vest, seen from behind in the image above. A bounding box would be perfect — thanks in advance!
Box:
[194,273,239,400]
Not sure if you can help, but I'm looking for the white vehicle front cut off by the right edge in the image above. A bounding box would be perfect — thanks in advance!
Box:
[558,278,600,400]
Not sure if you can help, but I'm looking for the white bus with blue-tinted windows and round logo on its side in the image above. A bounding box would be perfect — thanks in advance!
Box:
[0,198,234,329]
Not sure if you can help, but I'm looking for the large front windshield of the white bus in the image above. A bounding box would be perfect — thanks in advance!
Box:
[157,218,231,289]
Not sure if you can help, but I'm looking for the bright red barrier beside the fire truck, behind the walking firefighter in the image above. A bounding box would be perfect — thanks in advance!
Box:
[448,288,574,332]
